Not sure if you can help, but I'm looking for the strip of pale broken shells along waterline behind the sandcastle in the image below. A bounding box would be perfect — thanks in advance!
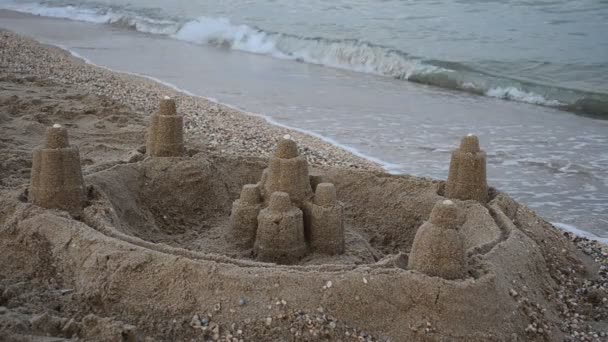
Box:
[0,30,382,171]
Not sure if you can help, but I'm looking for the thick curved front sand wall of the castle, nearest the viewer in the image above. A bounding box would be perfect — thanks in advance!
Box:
[2,203,529,340]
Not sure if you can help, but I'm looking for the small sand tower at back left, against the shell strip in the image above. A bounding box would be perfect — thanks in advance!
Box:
[146,97,184,157]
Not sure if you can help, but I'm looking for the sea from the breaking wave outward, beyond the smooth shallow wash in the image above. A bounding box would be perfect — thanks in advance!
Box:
[0,0,608,118]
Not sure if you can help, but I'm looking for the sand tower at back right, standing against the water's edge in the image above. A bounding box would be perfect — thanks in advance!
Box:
[445,134,488,203]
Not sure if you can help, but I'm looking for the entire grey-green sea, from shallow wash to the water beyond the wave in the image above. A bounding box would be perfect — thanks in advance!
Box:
[0,0,608,238]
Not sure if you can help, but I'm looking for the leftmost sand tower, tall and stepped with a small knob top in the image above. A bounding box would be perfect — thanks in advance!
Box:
[29,124,86,216]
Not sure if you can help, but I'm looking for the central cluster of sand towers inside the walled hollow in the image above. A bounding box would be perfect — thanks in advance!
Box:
[229,135,344,264]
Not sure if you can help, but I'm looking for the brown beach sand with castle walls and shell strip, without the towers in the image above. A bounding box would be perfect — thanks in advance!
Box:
[0,32,608,341]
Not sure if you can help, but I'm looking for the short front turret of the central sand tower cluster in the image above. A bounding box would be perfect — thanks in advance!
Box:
[254,191,307,264]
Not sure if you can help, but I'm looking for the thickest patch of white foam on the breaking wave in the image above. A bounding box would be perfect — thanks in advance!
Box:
[171,17,448,79]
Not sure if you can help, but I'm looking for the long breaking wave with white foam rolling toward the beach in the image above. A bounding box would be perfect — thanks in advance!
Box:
[0,1,608,119]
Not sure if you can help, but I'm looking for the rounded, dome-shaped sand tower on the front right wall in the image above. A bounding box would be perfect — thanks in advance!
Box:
[408,200,466,279]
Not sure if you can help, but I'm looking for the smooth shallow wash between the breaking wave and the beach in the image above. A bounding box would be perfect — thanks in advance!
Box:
[0,13,608,236]
